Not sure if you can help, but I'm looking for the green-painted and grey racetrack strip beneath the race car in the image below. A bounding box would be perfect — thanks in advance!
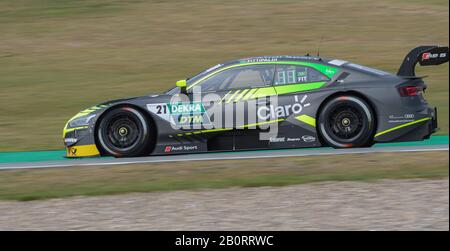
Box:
[0,136,449,170]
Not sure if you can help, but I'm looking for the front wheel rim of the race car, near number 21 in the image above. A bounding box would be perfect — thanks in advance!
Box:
[105,114,141,151]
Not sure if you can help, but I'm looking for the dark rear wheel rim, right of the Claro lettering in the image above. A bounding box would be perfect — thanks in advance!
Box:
[327,103,367,142]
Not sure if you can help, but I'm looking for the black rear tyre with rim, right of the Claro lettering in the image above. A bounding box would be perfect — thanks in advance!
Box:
[317,96,375,148]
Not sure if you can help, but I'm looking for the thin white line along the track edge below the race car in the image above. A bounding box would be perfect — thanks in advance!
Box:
[0,145,449,170]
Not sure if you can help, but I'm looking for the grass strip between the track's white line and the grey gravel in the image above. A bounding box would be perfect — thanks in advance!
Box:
[0,152,449,200]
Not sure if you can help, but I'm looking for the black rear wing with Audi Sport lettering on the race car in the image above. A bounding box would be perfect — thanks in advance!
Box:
[397,45,449,77]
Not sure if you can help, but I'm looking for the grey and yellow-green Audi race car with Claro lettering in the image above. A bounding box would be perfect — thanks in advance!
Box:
[63,46,449,157]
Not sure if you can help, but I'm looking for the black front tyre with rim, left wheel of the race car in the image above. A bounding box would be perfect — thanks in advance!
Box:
[97,107,152,157]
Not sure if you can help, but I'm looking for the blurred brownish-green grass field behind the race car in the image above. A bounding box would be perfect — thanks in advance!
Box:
[0,0,449,151]
